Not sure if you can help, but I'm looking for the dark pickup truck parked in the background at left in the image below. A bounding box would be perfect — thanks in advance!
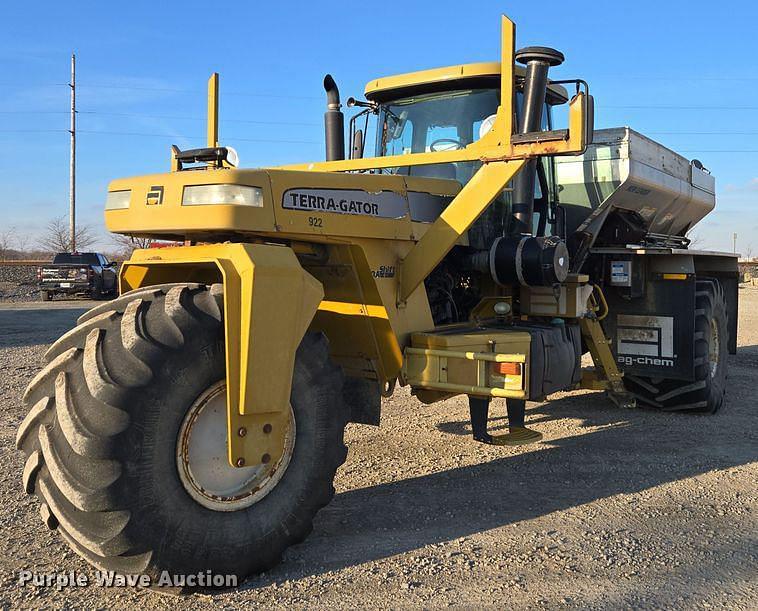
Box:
[37,252,117,301]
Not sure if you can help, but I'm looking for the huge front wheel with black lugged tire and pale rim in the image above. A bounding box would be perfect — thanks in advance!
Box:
[17,284,347,585]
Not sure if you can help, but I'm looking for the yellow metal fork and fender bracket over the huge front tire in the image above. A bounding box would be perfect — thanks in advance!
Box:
[120,244,324,467]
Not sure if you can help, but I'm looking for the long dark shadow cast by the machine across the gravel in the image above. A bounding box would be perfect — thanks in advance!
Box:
[244,384,758,588]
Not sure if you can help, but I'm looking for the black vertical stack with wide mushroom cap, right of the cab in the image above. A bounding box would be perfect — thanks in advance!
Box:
[513,47,564,235]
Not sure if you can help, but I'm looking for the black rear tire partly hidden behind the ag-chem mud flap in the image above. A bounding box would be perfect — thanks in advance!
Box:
[624,279,729,414]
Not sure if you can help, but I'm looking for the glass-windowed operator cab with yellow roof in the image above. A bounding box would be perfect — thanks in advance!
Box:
[362,62,568,241]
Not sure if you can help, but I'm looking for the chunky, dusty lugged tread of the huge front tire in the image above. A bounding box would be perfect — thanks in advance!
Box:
[16,283,347,588]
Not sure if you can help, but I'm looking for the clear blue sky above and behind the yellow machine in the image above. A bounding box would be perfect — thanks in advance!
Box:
[0,0,758,256]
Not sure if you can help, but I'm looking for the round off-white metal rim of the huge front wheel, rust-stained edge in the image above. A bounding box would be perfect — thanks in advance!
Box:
[176,381,295,511]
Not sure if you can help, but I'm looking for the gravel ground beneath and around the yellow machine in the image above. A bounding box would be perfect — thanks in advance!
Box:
[0,288,758,609]
